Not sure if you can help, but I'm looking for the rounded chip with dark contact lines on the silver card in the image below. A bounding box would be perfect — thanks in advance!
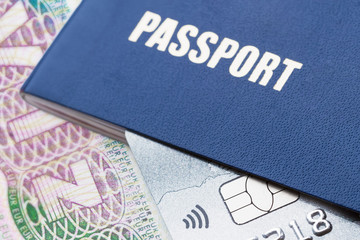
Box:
[220,176,299,224]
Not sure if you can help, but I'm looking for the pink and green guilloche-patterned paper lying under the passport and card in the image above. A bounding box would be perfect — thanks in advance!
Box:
[0,0,167,240]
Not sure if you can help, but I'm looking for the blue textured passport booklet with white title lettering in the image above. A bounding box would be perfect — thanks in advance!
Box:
[22,0,360,211]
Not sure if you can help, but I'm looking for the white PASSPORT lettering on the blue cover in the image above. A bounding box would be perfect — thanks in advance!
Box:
[128,11,303,91]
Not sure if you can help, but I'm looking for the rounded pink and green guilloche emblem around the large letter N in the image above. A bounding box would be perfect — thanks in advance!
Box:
[20,148,125,239]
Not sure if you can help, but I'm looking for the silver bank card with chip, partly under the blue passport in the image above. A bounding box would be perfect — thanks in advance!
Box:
[126,132,360,240]
